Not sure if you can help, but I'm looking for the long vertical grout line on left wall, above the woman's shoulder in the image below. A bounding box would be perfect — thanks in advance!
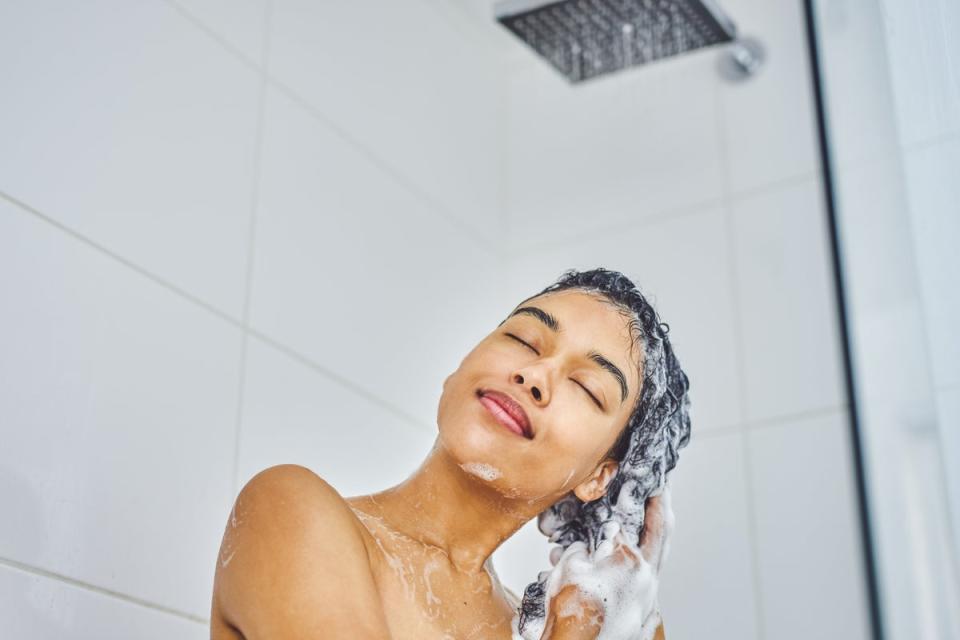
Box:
[231,0,273,495]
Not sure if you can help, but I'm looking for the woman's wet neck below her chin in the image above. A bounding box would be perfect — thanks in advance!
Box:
[360,438,552,574]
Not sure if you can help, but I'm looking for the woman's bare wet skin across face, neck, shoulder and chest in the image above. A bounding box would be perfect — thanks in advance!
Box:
[211,291,662,640]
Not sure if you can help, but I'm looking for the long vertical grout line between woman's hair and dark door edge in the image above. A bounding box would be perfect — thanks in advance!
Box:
[714,78,766,640]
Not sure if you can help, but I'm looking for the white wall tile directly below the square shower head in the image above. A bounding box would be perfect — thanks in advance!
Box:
[505,54,722,251]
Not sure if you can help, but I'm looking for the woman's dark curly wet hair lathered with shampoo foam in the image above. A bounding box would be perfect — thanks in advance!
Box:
[518,268,690,631]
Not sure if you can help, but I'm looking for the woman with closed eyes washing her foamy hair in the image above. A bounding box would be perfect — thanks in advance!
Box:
[211,269,690,640]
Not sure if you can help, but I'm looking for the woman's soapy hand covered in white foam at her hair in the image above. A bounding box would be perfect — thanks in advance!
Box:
[541,487,673,640]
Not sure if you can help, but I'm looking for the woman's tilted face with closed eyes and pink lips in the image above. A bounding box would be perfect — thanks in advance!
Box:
[437,289,640,500]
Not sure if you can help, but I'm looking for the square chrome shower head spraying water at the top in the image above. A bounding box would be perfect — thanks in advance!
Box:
[494,0,737,82]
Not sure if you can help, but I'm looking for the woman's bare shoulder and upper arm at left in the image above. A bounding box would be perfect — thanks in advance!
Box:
[214,465,390,640]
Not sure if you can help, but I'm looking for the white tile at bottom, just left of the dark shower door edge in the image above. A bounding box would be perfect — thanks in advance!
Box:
[749,411,871,640]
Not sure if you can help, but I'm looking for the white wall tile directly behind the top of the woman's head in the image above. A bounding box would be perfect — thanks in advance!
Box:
[506,209,741,431]
